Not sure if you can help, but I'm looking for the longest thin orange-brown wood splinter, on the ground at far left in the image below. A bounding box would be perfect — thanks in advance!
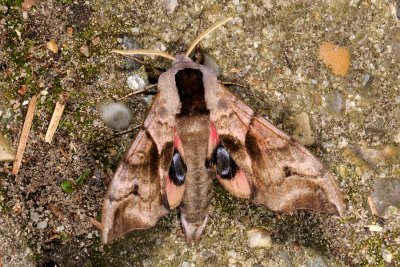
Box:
[12,96,37,175]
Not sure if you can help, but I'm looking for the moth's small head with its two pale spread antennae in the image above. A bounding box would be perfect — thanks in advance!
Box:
[111,18,232,68]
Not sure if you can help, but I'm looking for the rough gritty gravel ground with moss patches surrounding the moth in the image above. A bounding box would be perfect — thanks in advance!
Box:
[0,0,400,267]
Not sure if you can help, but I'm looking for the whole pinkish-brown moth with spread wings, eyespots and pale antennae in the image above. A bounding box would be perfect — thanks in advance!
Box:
[102,19,344,243]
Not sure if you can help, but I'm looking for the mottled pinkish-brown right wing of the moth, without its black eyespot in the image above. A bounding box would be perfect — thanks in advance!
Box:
[210,85,344,217]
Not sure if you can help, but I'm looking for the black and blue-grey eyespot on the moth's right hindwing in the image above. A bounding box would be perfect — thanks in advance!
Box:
[210,144,239,179]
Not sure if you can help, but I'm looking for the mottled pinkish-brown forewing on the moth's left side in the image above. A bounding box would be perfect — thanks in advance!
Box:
[102,96,173,243]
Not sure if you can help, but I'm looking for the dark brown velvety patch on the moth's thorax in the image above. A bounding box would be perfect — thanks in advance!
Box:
[175,68,209,116]
